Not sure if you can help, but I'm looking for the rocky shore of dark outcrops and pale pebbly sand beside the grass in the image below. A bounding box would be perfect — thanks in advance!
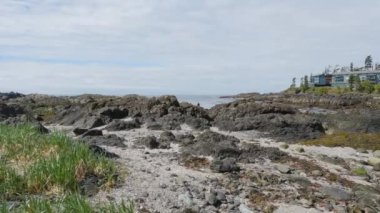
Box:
[0,93,380,213]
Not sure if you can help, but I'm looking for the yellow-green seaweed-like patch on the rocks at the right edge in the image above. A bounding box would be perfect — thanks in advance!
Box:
[302,132,380,150]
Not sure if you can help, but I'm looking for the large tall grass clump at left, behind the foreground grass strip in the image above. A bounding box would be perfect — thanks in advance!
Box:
[0,125,116,200]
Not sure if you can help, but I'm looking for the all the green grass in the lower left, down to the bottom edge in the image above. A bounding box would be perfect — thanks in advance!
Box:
[0,125,133,212]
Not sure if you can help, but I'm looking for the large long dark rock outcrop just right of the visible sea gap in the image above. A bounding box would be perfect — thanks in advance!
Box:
[211,99,324,141]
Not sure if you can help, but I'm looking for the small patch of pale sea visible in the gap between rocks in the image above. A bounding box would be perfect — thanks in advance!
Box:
[176,95,234,109]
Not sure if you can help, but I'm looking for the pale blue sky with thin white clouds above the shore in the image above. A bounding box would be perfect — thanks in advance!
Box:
[0,0,380,95]
